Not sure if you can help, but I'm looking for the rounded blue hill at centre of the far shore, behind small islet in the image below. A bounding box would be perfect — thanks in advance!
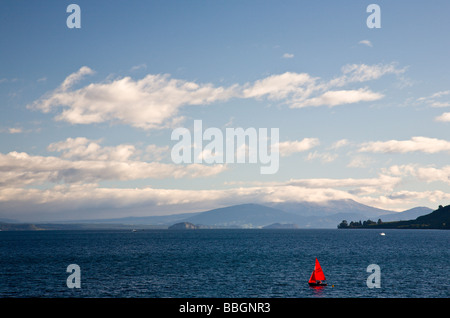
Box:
[178,203,303,228]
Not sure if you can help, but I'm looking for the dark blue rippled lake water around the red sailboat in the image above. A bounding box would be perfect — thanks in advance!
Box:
[0,230,450,298]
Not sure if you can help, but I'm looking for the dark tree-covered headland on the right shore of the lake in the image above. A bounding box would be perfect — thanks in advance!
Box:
[338,205,450,229]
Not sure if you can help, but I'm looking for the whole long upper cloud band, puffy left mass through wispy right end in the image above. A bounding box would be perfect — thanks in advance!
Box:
[28,64,405,129]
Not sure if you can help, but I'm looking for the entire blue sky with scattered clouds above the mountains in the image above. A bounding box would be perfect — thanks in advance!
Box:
[0,0,450,222]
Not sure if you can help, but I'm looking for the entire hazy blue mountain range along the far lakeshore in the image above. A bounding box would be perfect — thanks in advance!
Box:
[37,200,432,228]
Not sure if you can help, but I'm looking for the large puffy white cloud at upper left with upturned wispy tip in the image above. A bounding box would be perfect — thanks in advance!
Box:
[29,67,239,129]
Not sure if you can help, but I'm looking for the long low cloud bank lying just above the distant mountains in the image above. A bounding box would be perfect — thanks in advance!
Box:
[0,175,398,217]
